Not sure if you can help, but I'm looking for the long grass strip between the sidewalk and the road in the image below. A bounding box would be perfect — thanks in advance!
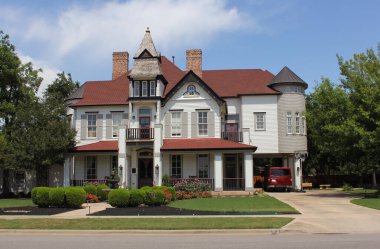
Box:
[0,217,293,230]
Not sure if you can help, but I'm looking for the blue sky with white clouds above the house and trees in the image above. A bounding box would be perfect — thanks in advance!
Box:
[0,0,380,92]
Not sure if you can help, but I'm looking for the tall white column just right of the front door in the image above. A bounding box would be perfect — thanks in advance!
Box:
[153,124,162,186]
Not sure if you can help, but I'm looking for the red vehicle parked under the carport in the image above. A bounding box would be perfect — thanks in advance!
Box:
[264,167,292,191]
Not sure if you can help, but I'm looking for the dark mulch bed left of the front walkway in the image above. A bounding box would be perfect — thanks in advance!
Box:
[0,207,75,215]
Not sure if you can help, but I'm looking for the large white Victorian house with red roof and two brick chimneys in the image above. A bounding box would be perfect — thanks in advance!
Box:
[56,30,308,191]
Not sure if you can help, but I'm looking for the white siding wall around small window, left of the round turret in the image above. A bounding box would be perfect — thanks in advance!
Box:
[241,95,278,154]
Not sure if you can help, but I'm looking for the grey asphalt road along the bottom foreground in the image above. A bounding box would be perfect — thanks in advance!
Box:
[0,231,380,249]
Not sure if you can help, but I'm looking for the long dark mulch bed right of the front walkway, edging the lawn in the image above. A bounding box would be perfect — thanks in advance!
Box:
[88,206,268,216]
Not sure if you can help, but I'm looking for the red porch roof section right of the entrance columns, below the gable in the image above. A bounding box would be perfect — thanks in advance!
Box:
[161,138,257,152]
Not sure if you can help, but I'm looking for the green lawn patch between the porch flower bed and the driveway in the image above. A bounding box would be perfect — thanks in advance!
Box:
[169,196,299,213]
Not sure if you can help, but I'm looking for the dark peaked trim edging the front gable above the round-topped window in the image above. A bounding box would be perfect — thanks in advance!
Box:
[162,70,225,106]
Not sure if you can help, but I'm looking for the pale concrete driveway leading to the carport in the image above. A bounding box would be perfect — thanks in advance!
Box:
[269,190,380,234]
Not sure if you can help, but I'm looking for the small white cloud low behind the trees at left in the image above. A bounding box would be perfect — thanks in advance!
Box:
[18,53,60,97]
